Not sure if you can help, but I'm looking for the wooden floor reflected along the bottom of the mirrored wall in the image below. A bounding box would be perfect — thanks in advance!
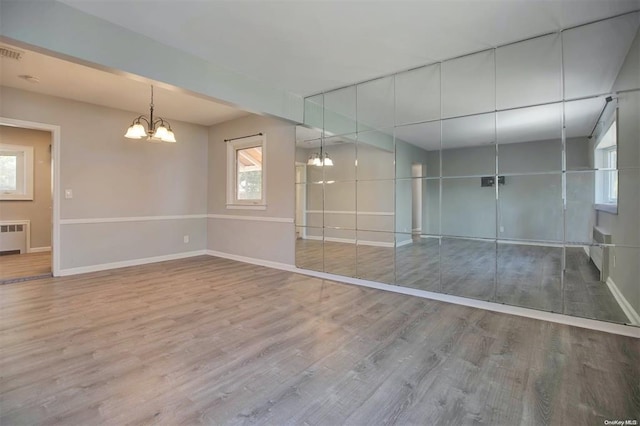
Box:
[296,238,629,323]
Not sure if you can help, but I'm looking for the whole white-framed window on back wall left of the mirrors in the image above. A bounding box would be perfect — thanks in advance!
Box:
[227,135,267,209]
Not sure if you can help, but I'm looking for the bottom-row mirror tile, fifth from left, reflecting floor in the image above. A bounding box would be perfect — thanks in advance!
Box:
[440,238,496,300]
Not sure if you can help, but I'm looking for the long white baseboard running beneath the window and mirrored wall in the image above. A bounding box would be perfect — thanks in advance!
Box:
[207,250,640,338]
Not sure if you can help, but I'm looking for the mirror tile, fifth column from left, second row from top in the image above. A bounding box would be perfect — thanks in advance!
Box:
[442,113,496,176]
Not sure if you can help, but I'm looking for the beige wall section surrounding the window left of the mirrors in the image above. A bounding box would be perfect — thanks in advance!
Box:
[209,115,295,265]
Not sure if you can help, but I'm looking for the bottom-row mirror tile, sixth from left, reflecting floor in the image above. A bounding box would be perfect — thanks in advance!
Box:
[496,242,563,312]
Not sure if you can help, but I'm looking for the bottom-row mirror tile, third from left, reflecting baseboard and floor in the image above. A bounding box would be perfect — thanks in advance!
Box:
[357,231,395,284]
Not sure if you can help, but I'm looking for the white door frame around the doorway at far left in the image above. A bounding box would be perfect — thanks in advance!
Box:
[0,116,61,277]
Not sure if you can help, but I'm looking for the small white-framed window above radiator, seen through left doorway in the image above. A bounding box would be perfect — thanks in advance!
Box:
[0,144,33,200]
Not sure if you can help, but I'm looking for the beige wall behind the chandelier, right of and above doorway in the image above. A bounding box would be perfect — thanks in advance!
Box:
[0,87,208,269]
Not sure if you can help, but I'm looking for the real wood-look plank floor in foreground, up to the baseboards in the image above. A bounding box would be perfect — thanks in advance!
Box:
[0,256,640,426]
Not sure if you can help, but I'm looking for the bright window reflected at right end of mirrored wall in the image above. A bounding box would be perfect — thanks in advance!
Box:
[594,116,618,213]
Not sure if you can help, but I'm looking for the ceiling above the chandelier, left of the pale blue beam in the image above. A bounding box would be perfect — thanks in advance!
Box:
[0,44,248,126]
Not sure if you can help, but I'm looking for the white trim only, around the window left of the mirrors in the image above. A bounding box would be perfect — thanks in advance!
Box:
[227,135,267,210]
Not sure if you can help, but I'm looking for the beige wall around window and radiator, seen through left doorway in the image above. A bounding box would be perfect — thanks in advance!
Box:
[0,126,53,248]
